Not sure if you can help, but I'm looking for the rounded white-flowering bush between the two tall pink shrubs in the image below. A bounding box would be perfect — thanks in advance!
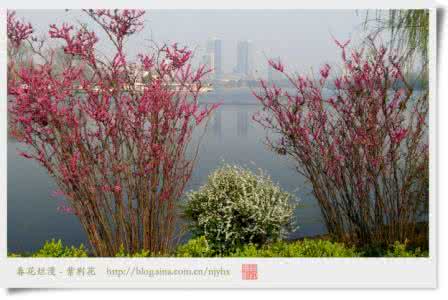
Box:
[185,166,296,254]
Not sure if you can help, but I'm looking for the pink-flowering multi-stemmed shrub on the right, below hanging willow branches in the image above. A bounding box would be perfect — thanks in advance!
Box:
[254,40,428,245]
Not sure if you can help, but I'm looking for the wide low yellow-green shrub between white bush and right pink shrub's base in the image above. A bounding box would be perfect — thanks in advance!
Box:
[232,239,359,257]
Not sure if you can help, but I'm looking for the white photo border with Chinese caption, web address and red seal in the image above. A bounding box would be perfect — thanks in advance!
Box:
[0,0,438,288]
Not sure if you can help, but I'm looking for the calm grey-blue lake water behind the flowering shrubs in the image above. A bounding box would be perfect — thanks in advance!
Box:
[7,89,326,252]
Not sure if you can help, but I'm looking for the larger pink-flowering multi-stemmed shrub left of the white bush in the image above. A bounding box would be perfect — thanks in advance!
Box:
[8,10,216,256]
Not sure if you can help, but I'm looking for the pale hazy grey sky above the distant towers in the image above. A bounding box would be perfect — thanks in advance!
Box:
[17,10,382,76]
